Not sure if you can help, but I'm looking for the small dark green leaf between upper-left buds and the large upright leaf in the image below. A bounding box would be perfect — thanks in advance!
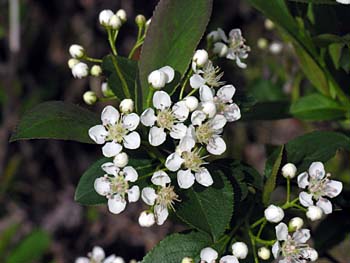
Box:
[102,55,138,101]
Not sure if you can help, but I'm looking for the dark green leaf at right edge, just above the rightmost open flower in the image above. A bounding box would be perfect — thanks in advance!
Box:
[286,131,350,171]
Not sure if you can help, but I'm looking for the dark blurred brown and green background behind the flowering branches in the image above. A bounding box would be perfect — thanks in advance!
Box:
[0,0,350,263]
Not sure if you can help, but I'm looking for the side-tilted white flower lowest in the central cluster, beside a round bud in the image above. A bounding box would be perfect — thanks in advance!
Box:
[141,171,179,225]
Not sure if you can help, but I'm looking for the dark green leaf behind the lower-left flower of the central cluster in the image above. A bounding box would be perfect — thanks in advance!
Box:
[74,158,156,205]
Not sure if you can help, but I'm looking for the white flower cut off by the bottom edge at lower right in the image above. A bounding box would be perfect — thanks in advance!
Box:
[272,223,316,263]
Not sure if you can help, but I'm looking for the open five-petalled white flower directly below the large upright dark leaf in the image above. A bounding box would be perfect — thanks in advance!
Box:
[141,91,189,146]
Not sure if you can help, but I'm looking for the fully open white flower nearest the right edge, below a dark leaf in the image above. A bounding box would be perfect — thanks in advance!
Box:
[298,162,343,214]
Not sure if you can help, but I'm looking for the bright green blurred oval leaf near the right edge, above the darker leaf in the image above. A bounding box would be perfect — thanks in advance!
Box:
[290,93,346,121]
